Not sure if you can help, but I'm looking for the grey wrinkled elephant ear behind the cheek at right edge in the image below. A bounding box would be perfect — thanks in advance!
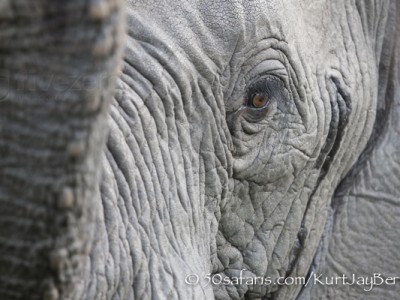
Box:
[299,1,400,299]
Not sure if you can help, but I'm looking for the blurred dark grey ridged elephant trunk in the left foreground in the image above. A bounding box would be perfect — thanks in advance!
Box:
[0,0,124,299]
